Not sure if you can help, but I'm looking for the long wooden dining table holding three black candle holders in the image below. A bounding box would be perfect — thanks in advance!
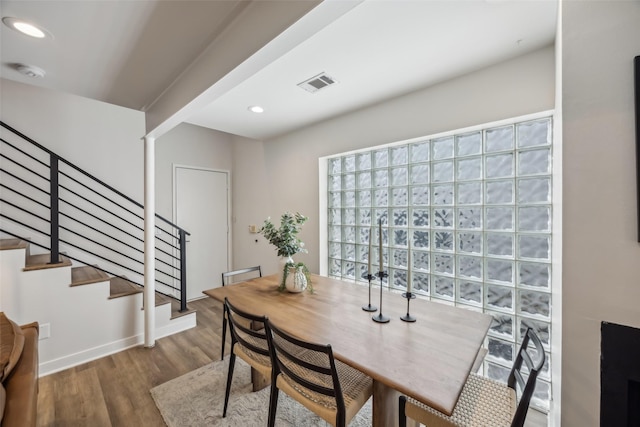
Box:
[204,275,492,427]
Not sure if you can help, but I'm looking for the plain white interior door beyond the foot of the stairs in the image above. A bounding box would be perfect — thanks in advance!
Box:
[174,166,229,300]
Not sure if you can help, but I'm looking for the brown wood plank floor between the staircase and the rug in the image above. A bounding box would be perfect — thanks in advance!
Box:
[38,298,547,427]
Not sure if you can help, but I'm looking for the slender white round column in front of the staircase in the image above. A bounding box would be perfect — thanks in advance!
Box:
[143,136,156,347]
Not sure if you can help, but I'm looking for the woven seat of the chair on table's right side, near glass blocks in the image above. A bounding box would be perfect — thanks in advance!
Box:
[406,374,517,427]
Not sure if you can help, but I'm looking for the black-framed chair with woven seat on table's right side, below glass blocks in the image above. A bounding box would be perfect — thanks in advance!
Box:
[399,328,546,427]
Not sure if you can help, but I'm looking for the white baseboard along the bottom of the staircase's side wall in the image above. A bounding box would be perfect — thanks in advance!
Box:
[38,312,196,377]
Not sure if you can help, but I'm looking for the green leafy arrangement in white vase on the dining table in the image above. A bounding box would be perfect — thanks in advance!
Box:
[259,212,313,292]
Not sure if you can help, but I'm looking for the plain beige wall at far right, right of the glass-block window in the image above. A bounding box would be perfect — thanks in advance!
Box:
[562,1,640,427]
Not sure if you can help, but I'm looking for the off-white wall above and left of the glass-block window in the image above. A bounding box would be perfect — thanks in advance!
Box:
[234,47,555,273]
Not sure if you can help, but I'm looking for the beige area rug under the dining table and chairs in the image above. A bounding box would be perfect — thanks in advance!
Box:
[151,357,371,427]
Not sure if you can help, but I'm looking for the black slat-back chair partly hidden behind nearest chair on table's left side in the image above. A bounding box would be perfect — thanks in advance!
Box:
[222,298,272,418]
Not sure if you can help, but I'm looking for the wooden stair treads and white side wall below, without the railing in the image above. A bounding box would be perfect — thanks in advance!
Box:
[0,238,196,375]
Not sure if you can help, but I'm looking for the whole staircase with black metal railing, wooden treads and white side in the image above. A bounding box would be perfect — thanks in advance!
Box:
[0,121,196,375]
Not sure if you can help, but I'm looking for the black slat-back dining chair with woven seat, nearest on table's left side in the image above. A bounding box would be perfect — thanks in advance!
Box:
[265,320,373,427]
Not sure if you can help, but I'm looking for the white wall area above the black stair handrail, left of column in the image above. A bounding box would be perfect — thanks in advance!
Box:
[0,79,145,203]
